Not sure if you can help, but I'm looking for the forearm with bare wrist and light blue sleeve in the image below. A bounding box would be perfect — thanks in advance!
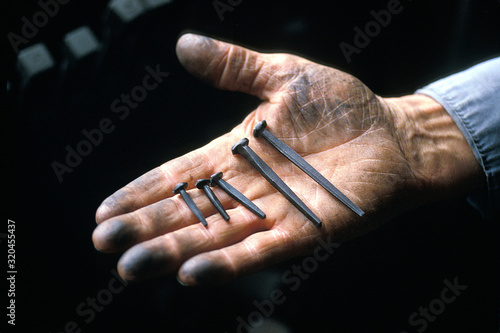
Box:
[385,58,500,219]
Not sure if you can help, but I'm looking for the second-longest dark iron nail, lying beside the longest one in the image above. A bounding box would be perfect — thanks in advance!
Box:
[231,138,321,227]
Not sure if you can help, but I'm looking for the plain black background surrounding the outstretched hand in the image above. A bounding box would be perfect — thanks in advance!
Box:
[4,0,500,333]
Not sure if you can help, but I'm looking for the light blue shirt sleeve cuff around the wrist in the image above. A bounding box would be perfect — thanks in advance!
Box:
[416,57,500,221]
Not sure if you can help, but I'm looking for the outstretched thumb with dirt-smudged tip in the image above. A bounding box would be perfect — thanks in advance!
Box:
[176,34,285,100]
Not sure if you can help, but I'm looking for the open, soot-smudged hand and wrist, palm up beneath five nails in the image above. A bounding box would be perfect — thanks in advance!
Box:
[93,34,481,285]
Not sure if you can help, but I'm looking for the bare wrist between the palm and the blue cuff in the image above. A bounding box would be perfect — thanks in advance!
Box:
[384,94,484,199]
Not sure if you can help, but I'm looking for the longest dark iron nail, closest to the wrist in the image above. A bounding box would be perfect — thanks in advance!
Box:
[253,120,365,216]
